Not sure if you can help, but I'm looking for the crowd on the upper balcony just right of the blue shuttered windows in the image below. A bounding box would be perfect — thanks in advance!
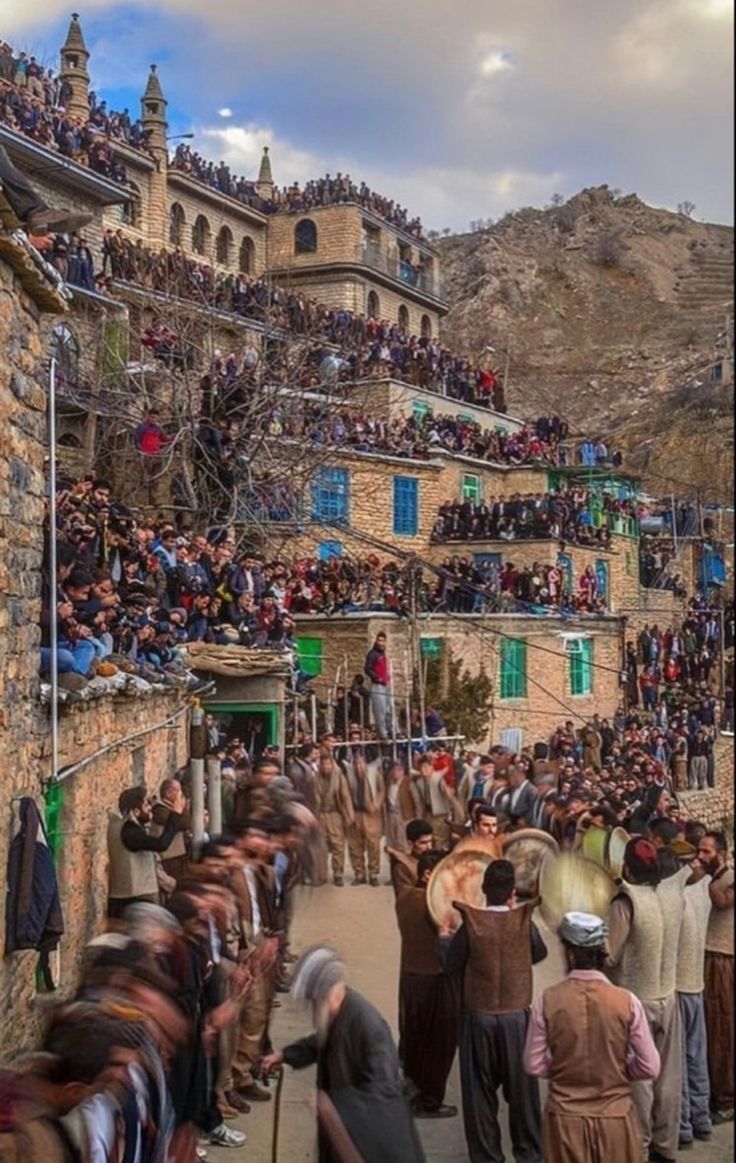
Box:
[431,486,636,547]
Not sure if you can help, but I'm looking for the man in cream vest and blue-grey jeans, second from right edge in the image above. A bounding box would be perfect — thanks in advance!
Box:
[659,849,712,1147]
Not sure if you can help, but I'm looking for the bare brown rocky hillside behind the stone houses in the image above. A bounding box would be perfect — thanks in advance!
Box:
[440,186,734,502]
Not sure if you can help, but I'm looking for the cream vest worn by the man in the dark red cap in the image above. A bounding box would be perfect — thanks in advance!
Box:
[610,877,683,1001]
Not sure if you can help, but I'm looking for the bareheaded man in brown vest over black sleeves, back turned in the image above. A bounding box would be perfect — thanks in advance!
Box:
[441,861,546,1163]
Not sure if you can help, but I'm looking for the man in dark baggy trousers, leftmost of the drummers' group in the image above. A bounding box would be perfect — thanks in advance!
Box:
[396,852,460,1119]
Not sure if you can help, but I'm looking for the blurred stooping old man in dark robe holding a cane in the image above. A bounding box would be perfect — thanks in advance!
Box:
[263,948,424,1163]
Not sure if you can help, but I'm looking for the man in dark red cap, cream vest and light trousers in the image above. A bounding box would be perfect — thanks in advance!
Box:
[606,837,689,1163]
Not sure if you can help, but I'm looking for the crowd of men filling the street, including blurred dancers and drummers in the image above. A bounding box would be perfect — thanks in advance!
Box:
[7,679,734,1163]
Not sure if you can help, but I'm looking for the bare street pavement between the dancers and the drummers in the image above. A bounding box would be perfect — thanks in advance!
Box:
[208,885,734,1163]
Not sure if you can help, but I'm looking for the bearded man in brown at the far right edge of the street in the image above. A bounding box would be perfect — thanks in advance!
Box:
[698,832,734,1123]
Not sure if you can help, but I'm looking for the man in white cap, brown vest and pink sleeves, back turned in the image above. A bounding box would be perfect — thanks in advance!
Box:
[524,913,659,1163]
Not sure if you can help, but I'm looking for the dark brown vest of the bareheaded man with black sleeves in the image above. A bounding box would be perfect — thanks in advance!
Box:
[453,901,536,1014]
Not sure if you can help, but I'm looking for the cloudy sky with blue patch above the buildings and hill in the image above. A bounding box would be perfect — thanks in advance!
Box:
[0,0,734,230]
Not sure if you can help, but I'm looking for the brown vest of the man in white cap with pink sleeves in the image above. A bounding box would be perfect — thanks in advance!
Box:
[542,977,631,1118]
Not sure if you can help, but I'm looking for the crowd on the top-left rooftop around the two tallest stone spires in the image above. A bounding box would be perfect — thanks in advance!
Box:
[0,42,153,184]
